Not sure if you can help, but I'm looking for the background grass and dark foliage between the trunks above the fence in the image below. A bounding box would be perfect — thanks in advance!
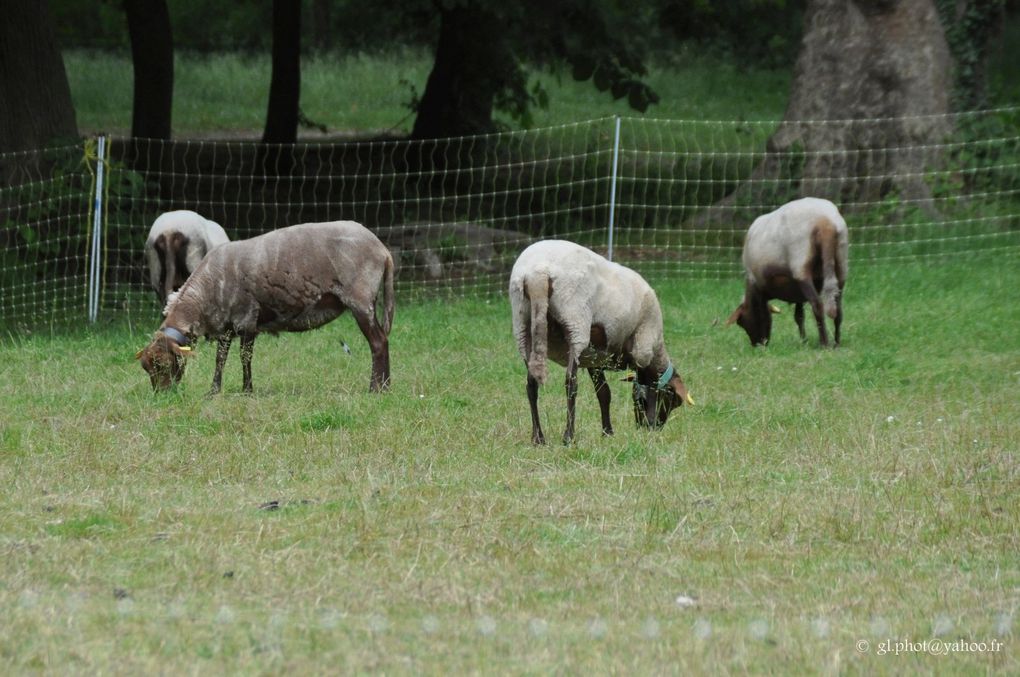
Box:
[51,0,1020,136]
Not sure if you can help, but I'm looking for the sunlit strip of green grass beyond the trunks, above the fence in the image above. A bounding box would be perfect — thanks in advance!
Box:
[64,50,789,140]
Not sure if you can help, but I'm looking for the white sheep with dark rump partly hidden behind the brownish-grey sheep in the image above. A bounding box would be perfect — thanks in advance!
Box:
[145,209,230,304]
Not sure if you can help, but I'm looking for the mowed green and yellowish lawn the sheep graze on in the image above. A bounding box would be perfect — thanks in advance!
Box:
[0,257,1020,674]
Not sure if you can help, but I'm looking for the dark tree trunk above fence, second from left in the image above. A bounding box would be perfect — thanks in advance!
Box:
[124,0,173,140]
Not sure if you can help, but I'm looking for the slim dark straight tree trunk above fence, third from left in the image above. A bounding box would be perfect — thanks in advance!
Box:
[262,0,301,144]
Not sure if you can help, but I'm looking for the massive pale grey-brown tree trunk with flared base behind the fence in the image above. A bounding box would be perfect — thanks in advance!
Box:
[694,0,952,225]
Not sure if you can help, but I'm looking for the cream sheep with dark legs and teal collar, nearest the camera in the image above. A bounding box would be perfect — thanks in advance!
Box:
[510,240,694,445]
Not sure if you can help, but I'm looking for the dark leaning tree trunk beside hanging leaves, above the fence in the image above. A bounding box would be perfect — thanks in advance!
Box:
[411,3,516,139]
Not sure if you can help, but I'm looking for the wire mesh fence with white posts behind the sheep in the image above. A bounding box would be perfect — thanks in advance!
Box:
[0,108,1020,333]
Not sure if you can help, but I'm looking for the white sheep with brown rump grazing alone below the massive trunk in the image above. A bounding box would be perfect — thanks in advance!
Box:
[726,198,849,346]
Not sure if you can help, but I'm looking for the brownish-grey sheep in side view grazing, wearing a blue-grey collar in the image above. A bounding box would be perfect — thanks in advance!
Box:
[136,221,394,395]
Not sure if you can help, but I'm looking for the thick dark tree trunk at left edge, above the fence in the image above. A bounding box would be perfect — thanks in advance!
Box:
[0,0,78,152]
